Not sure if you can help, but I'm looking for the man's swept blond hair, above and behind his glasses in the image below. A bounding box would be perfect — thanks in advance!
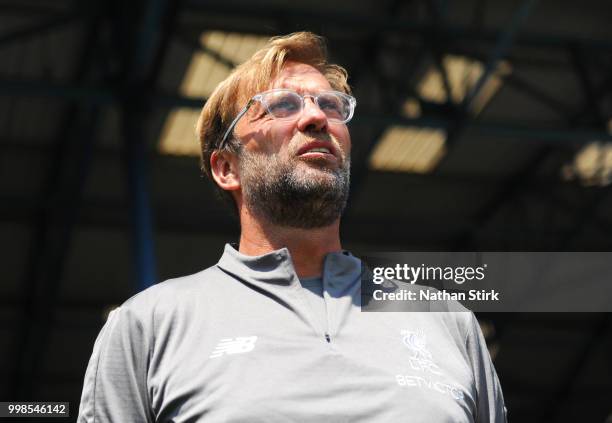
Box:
[196,32,351,205]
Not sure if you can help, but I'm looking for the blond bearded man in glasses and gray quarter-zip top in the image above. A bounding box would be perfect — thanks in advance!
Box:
[79,33,505,422]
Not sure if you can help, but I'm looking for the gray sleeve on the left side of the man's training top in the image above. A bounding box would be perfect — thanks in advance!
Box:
[77,307,154,423]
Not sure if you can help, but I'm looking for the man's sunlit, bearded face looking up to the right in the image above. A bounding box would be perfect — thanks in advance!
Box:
[234,62,351,229]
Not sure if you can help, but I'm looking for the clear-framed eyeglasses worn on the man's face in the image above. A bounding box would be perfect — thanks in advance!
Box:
[219,88,357,150]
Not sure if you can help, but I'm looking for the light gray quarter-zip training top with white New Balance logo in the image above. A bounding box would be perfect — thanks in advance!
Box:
[78,245,506,423]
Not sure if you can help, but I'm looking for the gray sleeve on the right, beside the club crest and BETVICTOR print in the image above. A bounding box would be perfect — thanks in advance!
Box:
[466,313,507,423]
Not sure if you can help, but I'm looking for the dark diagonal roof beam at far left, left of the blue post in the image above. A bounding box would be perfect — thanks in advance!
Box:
[10,2,101,399]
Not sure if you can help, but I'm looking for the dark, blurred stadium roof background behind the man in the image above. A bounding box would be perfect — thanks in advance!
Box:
[0,0,612,422]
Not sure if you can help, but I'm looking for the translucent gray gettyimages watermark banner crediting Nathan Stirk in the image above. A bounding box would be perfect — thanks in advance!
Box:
[359,252,612,312]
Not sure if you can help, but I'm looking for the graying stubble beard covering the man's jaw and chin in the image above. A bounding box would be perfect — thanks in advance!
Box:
[240,143,350,229]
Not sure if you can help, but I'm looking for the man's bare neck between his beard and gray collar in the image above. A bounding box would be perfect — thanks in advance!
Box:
[239,208,342,278]
